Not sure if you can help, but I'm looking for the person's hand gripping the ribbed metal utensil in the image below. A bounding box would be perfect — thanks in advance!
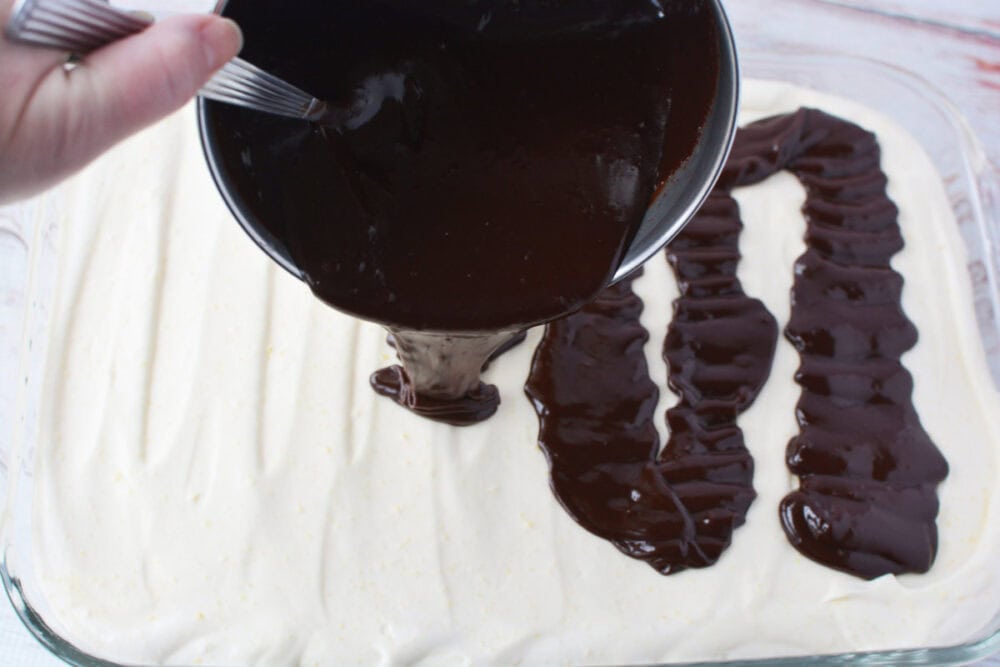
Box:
[0,0,243,204]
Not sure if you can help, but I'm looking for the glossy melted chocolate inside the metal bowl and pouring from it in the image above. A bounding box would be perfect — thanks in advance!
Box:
[206,0,719,424]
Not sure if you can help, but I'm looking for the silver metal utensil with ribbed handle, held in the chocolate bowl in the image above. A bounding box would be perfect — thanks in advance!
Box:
[4,0,328,122]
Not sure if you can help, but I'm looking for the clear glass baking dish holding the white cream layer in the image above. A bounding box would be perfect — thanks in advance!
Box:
[0,52,1000,667]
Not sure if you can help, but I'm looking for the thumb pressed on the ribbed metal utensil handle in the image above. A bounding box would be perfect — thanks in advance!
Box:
[67,15,243,159]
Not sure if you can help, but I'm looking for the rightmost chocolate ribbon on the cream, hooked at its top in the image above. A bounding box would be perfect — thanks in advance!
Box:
[725,109,948,579]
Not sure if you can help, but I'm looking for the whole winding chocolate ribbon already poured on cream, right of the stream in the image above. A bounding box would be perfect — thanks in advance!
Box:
[526,109,948,578]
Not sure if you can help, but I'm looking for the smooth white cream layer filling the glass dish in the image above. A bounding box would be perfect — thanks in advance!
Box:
[34,82,1000,667]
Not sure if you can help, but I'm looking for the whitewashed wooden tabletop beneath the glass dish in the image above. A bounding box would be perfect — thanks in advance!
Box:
[0,0,1000,667]
